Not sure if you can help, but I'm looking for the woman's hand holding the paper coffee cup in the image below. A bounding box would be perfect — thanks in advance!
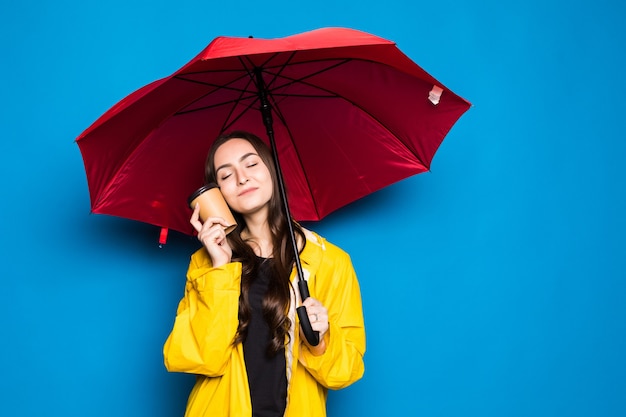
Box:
[189,204,233,267]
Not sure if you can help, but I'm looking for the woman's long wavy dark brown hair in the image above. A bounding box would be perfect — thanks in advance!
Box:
[205,131,306,354]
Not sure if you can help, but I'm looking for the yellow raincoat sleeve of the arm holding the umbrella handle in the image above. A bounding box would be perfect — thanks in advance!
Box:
[299,243,365,389]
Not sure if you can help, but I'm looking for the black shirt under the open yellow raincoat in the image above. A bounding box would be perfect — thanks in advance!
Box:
[243,259,287,417]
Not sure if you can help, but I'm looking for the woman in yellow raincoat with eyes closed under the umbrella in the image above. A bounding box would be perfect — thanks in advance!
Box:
[164,132,365,417]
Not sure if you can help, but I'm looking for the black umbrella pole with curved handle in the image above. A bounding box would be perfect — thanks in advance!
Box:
[254,68,320,346]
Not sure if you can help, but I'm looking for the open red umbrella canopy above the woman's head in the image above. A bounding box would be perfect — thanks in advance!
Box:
[77,28,470,234]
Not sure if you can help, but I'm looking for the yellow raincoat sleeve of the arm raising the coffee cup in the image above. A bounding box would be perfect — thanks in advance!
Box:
[163,250,241,376]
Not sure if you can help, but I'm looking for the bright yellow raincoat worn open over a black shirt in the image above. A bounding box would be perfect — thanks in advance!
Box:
[163,231,365,417]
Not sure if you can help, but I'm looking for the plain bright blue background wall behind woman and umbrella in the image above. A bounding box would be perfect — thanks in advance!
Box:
[0,0,626,417]
